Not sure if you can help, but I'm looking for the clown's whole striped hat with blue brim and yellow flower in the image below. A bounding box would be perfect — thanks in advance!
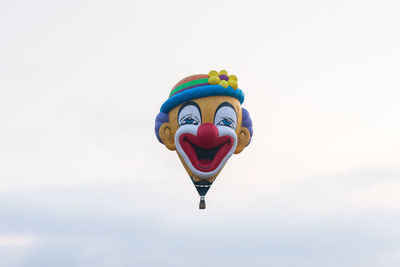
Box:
[160,70,244,113]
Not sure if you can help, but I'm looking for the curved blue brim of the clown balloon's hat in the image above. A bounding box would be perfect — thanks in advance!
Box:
[160,84,244,113]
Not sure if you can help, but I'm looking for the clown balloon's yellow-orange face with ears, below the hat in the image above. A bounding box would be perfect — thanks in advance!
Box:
[159,96,250,182]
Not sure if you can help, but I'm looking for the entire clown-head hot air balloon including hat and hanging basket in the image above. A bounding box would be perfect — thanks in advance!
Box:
[155,70,253,209]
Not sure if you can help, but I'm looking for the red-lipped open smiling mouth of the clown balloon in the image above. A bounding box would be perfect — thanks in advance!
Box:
[179,133,233,172]
